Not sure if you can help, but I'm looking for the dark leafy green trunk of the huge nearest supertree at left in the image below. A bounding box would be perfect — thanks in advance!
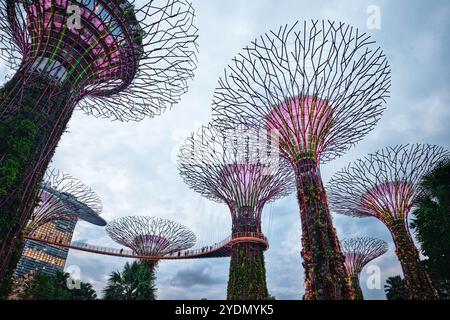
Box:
[0,72,73,291]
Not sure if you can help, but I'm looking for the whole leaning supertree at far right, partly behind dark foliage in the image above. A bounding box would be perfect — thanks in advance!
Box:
[327,144,450,299]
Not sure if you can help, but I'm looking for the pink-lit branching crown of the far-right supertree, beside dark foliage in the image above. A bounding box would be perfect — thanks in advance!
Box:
[327,144,450,227]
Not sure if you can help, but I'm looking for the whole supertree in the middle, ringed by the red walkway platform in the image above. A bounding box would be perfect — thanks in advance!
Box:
[178,124,294,300]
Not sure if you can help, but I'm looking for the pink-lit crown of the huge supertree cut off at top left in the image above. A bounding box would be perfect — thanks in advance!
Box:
[0,0,197,121]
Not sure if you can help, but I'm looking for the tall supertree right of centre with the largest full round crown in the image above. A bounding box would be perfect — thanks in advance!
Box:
[213,21,390,299]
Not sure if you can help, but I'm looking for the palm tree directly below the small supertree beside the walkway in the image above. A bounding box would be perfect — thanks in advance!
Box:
[103,261,156,300]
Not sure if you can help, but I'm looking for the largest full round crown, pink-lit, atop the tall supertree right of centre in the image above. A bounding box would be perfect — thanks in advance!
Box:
[213,20,390,164]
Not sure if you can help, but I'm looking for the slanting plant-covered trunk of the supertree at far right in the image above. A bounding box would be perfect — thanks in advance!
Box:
[390,219,439,300]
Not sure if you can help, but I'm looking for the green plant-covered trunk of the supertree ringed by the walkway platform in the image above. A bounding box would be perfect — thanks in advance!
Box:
[227,208,269,300]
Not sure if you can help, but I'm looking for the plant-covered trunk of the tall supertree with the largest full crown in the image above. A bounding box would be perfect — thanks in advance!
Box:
[296,162,353,300]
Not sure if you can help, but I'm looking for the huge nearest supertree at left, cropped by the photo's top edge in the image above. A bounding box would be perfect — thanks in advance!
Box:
[0,0,197,290]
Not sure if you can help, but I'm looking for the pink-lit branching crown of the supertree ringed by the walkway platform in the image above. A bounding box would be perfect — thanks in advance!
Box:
[178,124,294,224]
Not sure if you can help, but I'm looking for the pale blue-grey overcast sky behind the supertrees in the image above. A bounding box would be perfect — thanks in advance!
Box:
[1,0,450,299]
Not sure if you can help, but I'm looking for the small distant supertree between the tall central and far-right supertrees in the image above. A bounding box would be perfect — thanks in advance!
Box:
[342,237,388,300]
